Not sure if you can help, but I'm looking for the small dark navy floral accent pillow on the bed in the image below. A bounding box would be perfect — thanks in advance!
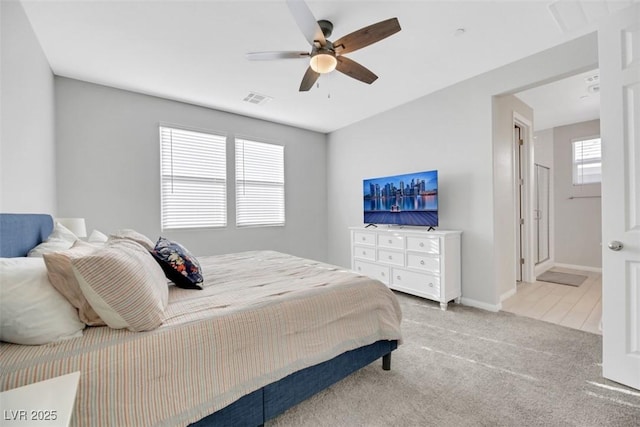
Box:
[151,237,204,289]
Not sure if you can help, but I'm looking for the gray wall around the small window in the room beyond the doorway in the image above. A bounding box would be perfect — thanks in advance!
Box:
[553,120,602,269]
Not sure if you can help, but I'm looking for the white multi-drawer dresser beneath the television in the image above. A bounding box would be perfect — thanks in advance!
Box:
[350,227,462,310]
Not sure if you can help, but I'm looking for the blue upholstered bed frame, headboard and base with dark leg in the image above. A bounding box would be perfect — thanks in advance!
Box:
[0,213,398,427]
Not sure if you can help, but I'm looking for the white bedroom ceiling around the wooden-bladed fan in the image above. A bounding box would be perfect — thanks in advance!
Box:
[21,0,632,132]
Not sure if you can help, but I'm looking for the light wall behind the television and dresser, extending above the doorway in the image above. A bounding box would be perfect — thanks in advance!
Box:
[328,34,598,309]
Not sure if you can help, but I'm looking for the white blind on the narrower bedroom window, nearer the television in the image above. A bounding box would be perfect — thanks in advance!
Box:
[236,139,284,227]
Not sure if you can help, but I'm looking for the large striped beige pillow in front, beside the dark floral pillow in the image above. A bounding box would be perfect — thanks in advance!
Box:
[71,239,169,331]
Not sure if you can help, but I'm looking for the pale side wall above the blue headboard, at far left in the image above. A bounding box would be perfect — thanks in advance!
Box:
[0,0,56,214]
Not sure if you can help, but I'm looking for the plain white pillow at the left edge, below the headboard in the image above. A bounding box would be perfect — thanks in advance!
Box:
[0,258,84,345]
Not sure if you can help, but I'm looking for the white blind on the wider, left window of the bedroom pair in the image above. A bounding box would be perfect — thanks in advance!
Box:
[160,126,227,230]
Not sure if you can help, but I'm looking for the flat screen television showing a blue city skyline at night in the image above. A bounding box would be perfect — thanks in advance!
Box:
[363,170,438,227]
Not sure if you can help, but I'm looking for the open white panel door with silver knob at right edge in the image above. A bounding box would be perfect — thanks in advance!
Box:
[598,4,640,389]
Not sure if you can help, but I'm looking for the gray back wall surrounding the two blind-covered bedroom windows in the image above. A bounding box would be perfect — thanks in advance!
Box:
[55,77,327,260]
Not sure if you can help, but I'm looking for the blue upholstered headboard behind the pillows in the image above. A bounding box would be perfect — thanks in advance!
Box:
[0,214,53,258]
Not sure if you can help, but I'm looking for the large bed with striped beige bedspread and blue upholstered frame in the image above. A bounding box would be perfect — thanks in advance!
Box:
[0,214,401,426]
